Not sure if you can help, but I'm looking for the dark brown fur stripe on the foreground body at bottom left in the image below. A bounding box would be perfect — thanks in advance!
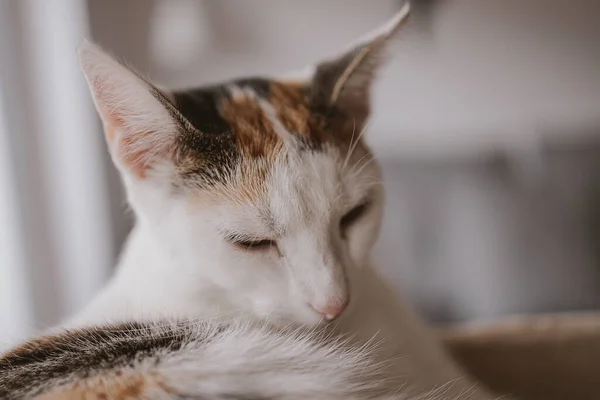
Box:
[0,324,201,400]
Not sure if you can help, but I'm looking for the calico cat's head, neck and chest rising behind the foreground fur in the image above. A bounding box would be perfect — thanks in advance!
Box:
[65,4,496,399]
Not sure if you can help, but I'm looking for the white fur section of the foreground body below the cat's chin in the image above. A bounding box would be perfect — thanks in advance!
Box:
[144,324,488,400]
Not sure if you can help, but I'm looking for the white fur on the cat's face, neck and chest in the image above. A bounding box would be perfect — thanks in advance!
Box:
[69,9,492,398]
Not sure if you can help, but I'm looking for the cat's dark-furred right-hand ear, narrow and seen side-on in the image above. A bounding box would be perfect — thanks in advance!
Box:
[311,2,410,120]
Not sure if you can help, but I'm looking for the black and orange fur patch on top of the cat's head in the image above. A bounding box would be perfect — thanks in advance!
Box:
[170,78,368,195]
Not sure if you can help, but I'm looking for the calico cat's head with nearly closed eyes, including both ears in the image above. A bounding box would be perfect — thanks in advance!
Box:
[80,6,408,324]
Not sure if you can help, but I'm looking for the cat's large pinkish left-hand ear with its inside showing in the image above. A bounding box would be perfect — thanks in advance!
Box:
[78,41,188,179]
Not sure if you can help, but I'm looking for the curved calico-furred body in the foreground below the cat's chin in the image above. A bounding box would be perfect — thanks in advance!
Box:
[0,321,470,400]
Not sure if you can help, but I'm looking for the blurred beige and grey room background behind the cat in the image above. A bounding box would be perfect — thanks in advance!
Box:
[0,0,600,343]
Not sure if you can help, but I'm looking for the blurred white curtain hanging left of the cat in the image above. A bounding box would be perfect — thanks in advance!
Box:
[0,0,114,345]
